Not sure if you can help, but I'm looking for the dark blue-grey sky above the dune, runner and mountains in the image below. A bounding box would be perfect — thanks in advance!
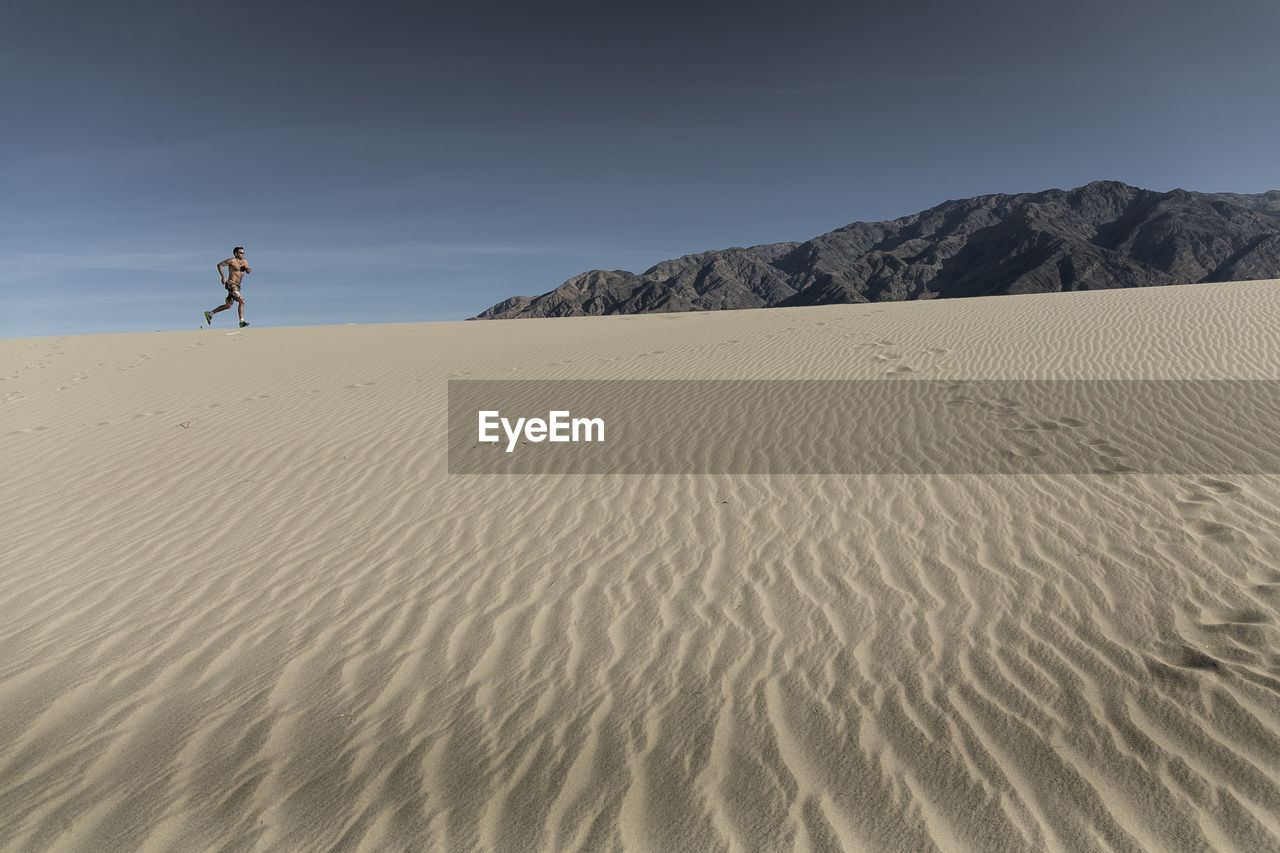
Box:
[0,0,1280,337]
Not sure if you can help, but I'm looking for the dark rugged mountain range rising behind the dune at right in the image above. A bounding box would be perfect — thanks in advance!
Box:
[475,181,1280,319]
